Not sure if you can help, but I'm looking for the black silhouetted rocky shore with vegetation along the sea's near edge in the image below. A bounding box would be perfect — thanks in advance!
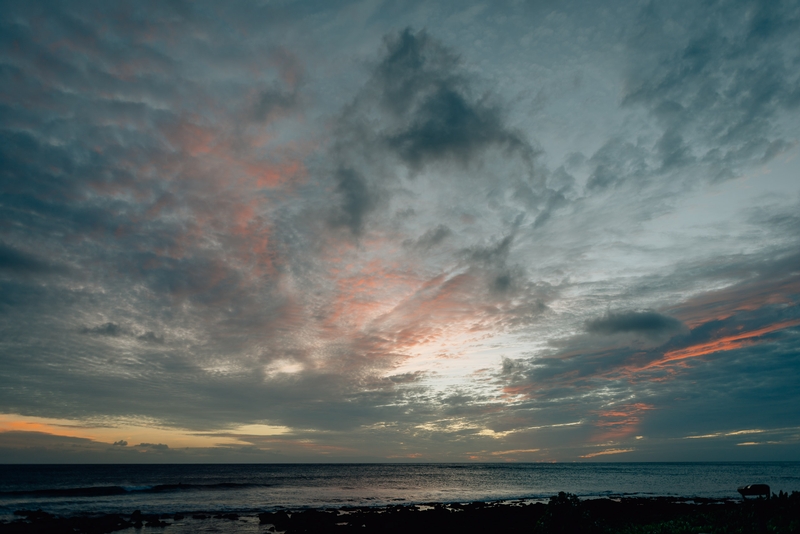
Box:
[0,492,800,534]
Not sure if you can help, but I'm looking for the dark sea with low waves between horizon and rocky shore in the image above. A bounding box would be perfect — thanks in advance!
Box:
[0,462,800,520]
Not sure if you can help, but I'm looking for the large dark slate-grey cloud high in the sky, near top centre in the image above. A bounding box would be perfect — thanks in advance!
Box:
[338,28,536,181]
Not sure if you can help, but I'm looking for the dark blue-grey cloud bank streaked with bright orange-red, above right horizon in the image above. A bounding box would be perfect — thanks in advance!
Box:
[496,244,799,452]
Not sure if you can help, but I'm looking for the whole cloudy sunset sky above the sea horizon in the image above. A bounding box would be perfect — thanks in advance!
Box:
[0,0,800,463]
